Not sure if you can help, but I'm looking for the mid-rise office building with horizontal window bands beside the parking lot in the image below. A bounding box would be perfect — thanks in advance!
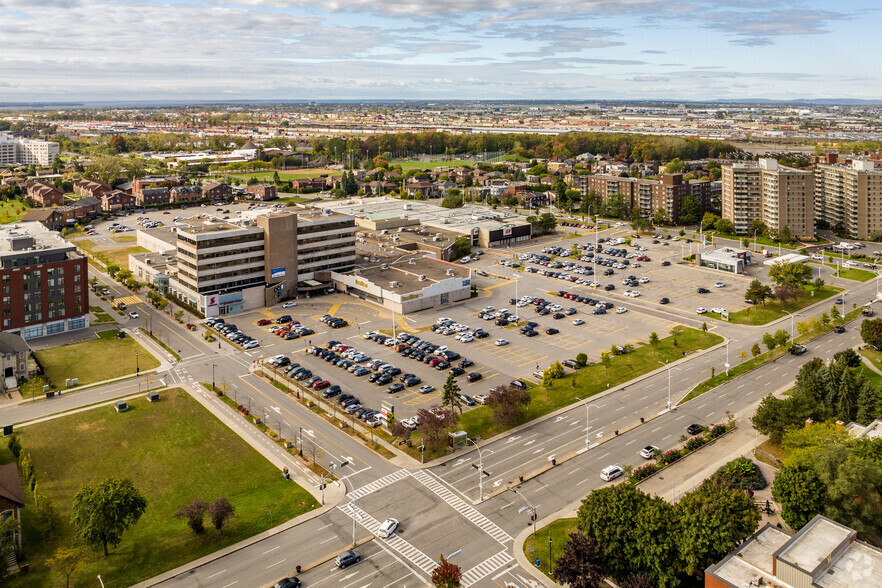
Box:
[165,210,356,316]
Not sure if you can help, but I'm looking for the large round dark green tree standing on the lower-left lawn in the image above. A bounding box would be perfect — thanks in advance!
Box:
[70,477,147,556]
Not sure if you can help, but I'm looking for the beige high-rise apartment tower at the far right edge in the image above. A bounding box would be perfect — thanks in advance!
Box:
[814,153,882,239]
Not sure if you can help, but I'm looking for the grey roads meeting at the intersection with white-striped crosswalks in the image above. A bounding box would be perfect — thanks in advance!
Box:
[15,249,875,588]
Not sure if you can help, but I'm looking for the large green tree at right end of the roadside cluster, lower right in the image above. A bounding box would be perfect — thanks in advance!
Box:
[674,478,760,575]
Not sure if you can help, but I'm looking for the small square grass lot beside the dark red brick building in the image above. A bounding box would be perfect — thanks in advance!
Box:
[34,329,159,388]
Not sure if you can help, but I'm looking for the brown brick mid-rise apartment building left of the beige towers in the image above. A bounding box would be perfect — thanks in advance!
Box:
[573,174,711,224]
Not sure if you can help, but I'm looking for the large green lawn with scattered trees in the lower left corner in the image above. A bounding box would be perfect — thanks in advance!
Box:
[3,388,318,588]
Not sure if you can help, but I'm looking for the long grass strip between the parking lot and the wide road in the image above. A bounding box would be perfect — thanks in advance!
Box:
[457,327,723,439]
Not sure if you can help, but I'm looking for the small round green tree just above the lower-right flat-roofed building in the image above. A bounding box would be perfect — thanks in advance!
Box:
[772,461,827,531]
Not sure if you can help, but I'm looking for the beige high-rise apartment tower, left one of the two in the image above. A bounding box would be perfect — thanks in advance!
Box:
[722,159,815,238]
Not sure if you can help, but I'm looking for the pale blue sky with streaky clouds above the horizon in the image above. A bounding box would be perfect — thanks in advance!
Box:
[0,0,882,102]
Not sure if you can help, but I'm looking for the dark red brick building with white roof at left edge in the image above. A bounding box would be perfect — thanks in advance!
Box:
[0,222,89,339]
